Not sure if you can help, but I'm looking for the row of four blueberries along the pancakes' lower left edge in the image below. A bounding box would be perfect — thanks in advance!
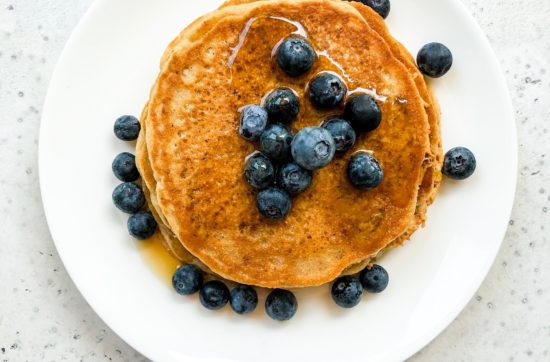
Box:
[172,264,298,321]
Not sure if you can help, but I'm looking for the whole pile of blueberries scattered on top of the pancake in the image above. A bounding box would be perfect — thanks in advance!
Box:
[239,36,384,219]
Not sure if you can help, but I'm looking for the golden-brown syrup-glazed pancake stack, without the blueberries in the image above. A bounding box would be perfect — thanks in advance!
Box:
[136,0,442,288]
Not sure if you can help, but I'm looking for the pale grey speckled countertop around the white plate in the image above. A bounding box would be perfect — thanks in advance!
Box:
[0,0,550,362]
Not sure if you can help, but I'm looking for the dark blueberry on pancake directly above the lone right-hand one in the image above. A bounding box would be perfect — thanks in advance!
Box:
[344,93,382,131]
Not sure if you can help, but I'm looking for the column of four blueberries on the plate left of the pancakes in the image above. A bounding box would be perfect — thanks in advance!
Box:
[112,116,157,240]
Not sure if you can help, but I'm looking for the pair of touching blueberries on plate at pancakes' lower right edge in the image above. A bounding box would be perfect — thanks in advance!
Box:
[331,264,389,308]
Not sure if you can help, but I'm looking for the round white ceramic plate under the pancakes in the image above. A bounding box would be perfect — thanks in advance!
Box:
[40,0,516,362]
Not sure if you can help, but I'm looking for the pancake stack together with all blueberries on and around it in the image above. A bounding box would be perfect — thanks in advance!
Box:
[109,0,475,321]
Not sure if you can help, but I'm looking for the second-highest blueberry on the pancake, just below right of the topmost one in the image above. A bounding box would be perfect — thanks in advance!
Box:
[309,73,347,108]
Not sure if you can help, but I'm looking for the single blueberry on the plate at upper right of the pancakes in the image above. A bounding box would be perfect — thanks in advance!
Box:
[416,43,453,78]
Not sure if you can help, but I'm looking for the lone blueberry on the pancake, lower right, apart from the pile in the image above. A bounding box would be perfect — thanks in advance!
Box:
[348,153,384,190]
